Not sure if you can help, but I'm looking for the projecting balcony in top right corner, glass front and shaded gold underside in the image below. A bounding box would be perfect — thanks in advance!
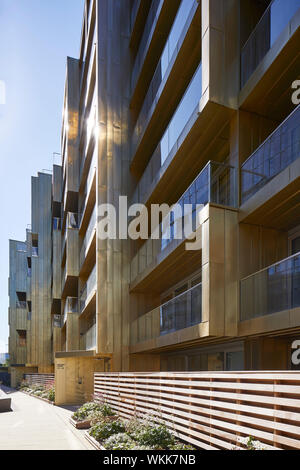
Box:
[240,0,300,119]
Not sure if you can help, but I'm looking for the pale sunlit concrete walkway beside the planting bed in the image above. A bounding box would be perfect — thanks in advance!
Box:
[0,387,93,450]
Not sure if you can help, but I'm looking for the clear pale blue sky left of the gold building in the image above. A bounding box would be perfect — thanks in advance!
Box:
[0,0,84,353]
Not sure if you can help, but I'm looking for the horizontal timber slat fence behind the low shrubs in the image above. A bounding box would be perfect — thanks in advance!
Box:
[94,371,300,450]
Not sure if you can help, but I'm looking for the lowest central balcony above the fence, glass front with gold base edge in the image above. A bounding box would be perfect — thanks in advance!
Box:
[131,283,202,352]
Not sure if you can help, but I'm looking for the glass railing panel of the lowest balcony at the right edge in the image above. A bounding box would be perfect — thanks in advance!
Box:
[240,253,300,321]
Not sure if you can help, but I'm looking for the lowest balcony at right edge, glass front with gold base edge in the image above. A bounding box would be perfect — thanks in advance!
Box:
[240,253,300,334]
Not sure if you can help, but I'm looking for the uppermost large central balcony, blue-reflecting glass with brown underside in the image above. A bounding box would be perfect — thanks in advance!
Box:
[133,0,201,167]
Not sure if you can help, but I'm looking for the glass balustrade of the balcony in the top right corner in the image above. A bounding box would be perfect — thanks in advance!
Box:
[241,0,300,87]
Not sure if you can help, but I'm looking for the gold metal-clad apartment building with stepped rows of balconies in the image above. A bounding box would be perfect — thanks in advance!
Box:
[10,0,300,396]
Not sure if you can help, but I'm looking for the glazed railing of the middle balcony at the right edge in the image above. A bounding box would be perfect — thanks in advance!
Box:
[241,106,300,203]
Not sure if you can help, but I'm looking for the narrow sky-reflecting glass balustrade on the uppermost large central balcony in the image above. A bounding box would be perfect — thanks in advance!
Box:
[135,0,195,141]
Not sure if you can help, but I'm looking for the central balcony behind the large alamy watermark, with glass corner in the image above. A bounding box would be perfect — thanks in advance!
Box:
[131,162,237,291]
